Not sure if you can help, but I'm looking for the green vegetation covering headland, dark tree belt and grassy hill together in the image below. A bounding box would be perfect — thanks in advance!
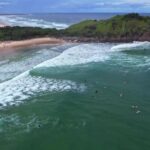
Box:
[0,13,150,41]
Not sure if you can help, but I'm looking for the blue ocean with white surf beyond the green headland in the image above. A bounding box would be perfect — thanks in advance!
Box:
[0,13,150,29]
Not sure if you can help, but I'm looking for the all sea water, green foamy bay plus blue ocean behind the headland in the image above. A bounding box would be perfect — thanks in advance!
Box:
[0,14,150,150]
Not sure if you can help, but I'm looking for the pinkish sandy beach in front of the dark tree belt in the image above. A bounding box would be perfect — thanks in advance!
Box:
[0,37,65,50]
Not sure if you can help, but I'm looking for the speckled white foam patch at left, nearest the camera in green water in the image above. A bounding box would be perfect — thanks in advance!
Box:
[0,74,85,106]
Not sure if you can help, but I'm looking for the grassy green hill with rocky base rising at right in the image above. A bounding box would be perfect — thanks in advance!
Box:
[65,13,150,41]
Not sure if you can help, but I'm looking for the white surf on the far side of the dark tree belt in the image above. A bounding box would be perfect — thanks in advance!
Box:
[0,15,69,29]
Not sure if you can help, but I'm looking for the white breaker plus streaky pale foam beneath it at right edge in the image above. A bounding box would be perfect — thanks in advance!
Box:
[111,41,150,71]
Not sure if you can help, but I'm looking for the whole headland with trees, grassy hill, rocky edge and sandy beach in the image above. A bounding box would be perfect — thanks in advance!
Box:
[0,13,150,44]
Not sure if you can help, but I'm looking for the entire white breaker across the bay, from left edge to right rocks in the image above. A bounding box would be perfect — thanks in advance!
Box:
[0,42,149,106]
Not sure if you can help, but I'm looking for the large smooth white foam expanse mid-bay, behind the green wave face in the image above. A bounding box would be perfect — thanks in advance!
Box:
[35,44,110,68]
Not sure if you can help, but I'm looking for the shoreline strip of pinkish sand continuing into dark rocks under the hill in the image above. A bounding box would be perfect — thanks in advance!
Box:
[0,37,150,50]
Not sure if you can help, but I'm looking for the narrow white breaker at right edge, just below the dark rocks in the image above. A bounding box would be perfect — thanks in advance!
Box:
[111,42,150,51]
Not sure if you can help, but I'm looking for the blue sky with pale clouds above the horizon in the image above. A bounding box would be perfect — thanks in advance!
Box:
[0,0,150,13]
